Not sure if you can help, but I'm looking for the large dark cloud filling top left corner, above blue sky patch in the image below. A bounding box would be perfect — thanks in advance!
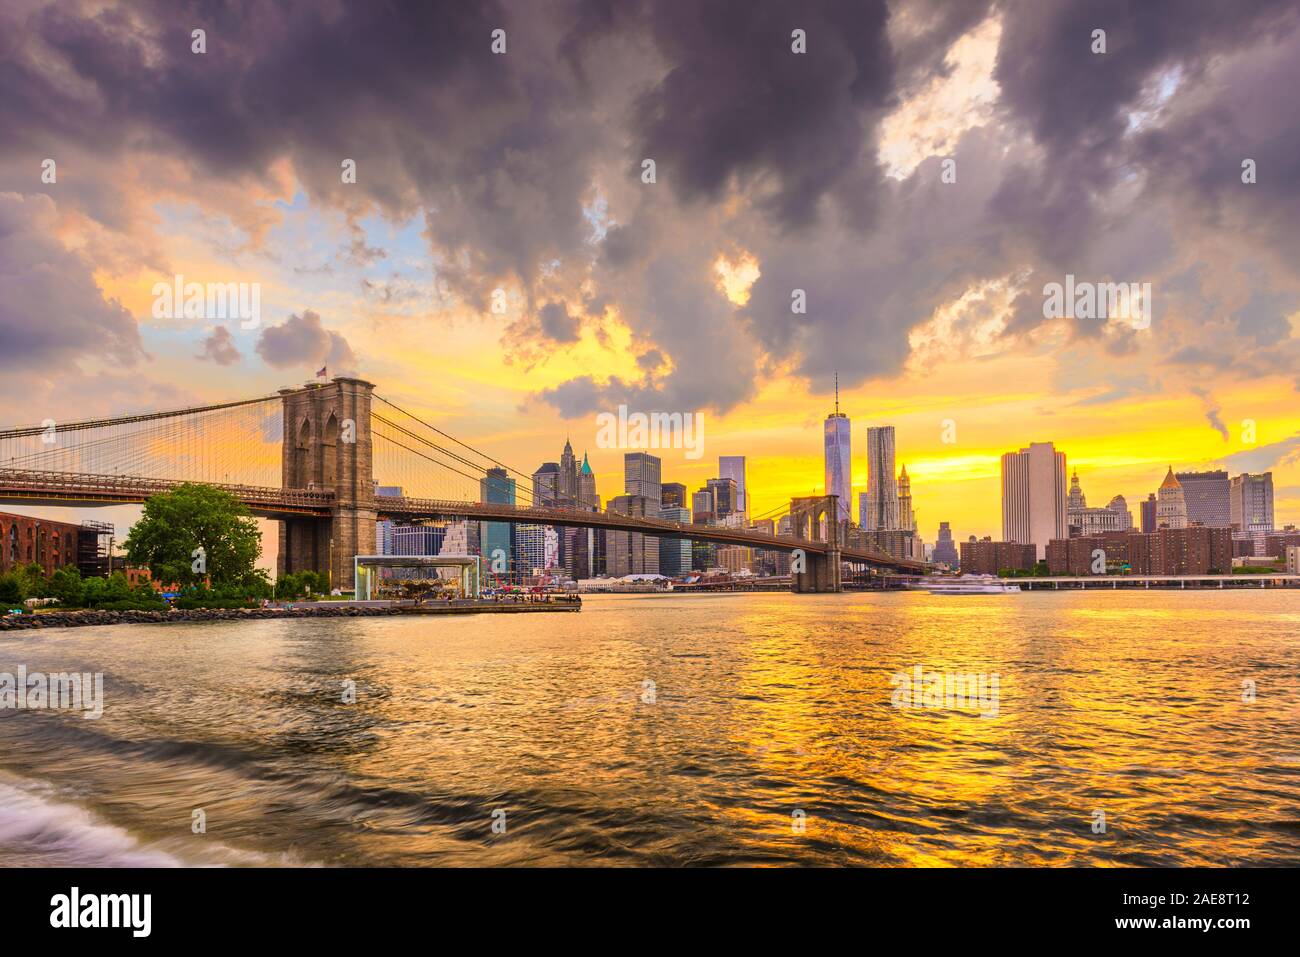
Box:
[0,1,598,296]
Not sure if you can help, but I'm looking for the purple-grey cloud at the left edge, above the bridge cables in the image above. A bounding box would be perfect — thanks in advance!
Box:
[0,192,144,371]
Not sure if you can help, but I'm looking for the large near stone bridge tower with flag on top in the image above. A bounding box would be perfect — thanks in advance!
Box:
[278,376,376,589]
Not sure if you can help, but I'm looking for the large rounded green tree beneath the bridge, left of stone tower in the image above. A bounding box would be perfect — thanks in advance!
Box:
[126,482,264,586]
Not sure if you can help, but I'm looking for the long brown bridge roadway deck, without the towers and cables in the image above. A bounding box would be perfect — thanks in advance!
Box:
[0,468,924,573]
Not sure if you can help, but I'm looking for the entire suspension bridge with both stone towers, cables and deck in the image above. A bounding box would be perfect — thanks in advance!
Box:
[0,377,924,592]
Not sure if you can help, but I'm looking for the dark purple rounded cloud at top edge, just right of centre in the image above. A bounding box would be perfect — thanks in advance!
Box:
[634,0,892,225]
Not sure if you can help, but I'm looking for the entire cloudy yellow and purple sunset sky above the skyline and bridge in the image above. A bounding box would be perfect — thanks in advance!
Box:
[0,0,1300,541]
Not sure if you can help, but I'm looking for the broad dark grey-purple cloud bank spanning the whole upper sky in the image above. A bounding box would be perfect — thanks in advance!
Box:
[0,0,1300,412]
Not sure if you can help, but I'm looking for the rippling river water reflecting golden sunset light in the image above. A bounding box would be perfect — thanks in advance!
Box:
[0,590,1300,866]
